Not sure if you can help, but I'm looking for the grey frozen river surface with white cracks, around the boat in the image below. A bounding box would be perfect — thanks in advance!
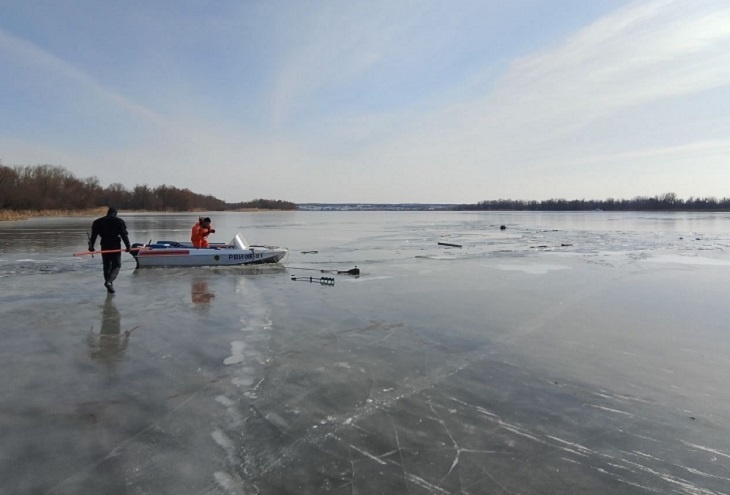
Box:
[0,212,730,495]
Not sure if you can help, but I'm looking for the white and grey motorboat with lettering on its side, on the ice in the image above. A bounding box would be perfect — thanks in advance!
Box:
[131,234,289,268]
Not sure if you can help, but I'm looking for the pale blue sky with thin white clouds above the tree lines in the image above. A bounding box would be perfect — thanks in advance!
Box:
[0,0,730,203]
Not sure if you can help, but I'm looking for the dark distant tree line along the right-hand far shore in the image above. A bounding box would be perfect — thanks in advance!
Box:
[455,193,730,211]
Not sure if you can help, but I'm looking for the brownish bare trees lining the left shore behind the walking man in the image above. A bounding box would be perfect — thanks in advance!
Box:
[0,164,297,211]
